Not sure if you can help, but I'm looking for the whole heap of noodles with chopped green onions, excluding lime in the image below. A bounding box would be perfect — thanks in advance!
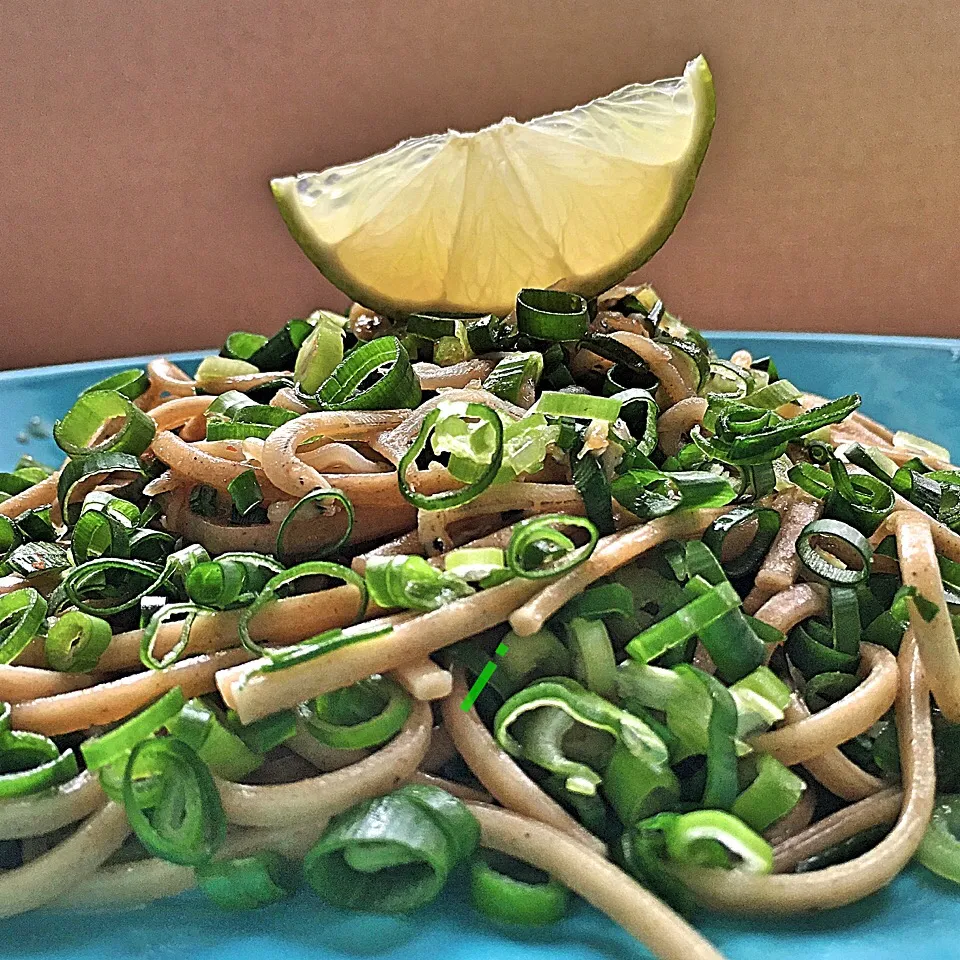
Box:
[0,287,960,960]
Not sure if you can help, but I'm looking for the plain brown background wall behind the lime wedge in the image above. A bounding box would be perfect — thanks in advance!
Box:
[0,0,960,366]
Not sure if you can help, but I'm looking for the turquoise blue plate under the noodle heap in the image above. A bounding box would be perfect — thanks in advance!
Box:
[0,333,960,960]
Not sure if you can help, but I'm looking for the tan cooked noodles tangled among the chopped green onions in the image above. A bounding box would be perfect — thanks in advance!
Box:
[0,320,960,960]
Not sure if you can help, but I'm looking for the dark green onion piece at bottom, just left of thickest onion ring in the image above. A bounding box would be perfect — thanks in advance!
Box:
[195,850,301,910]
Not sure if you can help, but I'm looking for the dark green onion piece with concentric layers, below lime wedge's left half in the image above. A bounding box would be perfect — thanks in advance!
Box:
[312,337,420,410]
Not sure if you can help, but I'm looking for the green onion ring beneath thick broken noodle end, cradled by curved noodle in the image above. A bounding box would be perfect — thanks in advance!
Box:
[298,675,413,750]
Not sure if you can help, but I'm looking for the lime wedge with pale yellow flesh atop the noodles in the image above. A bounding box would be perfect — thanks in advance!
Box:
[271,57,716,315]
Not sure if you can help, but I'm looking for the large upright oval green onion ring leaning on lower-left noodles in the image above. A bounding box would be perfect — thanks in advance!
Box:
[123,737,227,867]
